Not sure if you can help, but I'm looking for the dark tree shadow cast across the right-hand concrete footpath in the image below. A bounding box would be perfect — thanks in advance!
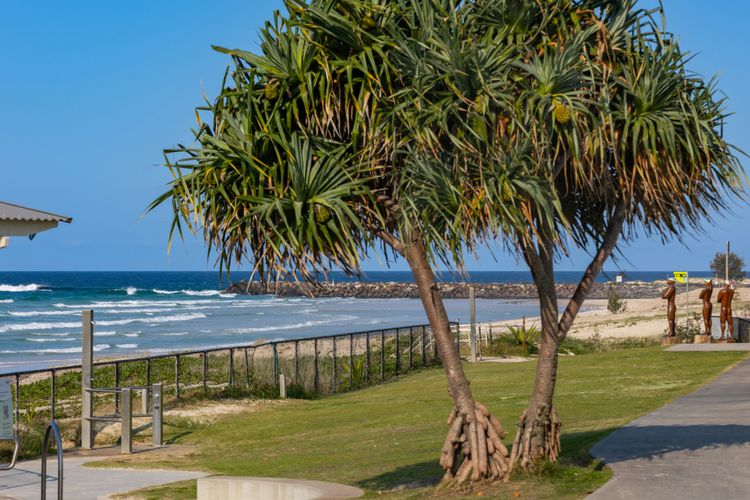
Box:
[591,424,750,464]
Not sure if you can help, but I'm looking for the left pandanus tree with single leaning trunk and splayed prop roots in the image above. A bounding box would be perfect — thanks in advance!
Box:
[152,0,555,481]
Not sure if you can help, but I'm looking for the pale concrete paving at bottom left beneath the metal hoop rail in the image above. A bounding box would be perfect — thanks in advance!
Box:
[0,455,206,500]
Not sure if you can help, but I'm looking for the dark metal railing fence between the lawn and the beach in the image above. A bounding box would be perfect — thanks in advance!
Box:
[0,323,459,452]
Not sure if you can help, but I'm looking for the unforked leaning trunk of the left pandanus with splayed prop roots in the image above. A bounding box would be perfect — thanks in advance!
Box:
[401,238,510,483]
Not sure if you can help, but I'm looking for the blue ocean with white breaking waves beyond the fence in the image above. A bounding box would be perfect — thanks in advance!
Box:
[0,272,712,373]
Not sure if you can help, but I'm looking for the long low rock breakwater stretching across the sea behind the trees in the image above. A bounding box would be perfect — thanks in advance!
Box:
[226,281,680,299]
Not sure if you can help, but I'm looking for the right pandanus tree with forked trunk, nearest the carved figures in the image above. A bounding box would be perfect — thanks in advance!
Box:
[488,0,744,468]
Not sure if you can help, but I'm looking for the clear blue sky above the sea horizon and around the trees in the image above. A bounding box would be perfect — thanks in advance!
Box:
[0,0,750,271]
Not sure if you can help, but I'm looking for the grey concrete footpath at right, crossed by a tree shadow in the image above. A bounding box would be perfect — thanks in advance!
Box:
[588,360,750,500]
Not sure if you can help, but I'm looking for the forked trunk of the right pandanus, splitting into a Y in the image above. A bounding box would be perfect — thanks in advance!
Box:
[511,200,627,469]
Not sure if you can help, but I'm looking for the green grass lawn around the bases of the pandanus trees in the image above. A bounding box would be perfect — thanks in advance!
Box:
[101,348,746,499]
